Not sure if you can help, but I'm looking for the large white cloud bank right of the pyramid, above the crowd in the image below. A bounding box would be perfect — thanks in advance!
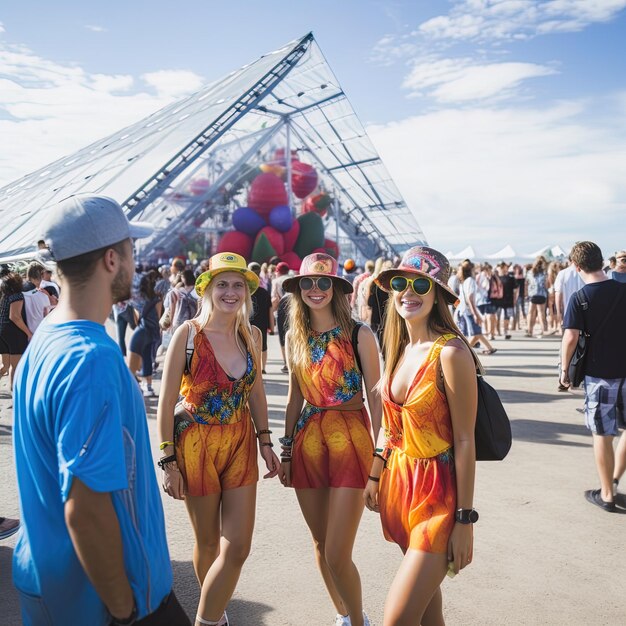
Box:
[368,93,626,254]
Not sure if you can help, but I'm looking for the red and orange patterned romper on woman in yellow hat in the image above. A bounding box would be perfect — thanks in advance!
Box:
[174,322,259,496]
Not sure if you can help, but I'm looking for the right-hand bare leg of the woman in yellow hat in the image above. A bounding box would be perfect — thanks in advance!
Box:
[198,483,256,622]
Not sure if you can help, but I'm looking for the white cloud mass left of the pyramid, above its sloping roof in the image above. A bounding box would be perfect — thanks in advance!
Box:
[0,42,201,186]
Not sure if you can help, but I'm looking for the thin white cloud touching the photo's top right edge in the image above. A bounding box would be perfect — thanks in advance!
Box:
[418,0,626,41]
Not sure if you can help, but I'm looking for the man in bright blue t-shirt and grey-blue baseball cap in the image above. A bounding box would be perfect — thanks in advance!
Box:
[13,196,189,626]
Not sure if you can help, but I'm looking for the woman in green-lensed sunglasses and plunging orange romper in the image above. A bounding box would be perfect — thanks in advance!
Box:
[364,246,478,626]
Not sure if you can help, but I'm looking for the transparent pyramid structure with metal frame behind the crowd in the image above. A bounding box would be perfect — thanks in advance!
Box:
[0,33,425,257]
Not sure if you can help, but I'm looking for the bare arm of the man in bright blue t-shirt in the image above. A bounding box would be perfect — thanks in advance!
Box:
[65,477,135,620]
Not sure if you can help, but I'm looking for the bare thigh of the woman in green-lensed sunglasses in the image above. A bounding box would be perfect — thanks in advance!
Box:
[383,550,448,626]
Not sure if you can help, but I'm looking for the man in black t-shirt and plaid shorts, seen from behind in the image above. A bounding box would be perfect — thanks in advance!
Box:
[559,241,626,512]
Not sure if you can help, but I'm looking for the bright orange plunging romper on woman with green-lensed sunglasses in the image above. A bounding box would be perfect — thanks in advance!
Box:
[379,334,456,553]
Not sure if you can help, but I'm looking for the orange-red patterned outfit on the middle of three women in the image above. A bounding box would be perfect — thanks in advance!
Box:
[291,327,374,489]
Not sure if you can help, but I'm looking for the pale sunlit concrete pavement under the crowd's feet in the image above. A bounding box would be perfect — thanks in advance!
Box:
[0,333,626,626]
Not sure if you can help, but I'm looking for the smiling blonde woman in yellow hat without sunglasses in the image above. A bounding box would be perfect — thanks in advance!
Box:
[157,253,281,626]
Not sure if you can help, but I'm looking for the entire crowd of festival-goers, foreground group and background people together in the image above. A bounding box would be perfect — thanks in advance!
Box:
[0,196,626,626]
